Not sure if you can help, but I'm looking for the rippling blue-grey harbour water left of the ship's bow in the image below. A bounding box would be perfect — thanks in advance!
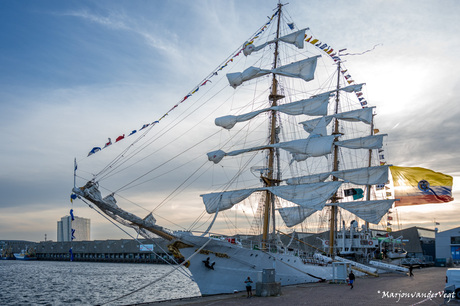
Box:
[0,260,200,305]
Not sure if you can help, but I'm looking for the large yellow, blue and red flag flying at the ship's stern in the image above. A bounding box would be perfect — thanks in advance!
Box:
[390,166,454,206]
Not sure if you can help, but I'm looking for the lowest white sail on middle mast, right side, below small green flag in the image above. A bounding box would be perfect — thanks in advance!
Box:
[337,199,395,224]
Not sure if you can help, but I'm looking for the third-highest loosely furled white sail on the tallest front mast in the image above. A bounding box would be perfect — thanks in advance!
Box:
[215,93,331,130]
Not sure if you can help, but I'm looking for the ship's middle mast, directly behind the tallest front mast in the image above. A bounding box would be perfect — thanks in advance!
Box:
[329,61,340,256]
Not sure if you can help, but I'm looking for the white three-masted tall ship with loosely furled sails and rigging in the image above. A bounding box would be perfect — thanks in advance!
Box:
[72,4,452,295]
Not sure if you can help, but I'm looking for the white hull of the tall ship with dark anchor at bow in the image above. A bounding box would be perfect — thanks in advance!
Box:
[176,236,332,295]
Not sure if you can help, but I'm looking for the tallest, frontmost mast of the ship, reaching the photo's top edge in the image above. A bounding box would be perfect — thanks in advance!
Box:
[262,3,283,248]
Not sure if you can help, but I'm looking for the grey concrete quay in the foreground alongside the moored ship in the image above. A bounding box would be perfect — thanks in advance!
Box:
[141,267,460,306]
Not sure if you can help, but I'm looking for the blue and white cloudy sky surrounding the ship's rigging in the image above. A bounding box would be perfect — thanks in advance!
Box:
[0,0,460,241]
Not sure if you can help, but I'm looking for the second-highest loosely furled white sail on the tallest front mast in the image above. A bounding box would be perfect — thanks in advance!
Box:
[227,55,320,88]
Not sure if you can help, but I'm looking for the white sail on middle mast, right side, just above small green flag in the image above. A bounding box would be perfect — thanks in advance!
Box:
[331,165,389,185]
